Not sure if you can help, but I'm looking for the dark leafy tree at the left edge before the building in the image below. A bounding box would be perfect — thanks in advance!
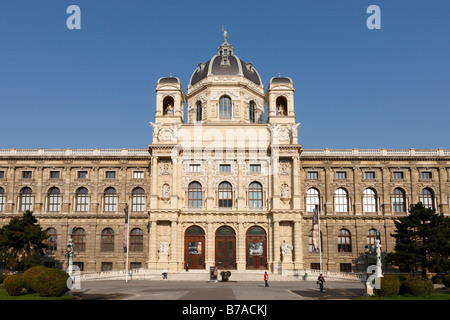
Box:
[0,210,48,270]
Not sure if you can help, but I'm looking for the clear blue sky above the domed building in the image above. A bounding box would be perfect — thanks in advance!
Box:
[0,0,450,149]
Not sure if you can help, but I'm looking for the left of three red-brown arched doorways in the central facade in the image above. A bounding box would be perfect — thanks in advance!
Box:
[184,226,205,269]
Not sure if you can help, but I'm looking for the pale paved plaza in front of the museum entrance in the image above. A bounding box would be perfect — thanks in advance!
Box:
[73,280,365,301]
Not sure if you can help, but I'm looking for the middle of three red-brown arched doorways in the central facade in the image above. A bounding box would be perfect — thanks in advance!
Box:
[216,226,236,269]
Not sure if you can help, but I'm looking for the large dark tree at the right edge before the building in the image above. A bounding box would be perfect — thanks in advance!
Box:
[387,202,450,277]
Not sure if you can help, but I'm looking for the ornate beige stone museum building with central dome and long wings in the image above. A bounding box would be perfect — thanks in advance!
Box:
[0,38,450,274]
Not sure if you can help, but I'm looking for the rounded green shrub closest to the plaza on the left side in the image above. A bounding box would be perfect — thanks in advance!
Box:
[35,269,69,297]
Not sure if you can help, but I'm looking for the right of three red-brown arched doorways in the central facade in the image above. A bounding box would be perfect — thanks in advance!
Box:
[246,226,267,269]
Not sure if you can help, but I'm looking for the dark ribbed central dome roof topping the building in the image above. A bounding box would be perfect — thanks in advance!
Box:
[189,41,262,86]
